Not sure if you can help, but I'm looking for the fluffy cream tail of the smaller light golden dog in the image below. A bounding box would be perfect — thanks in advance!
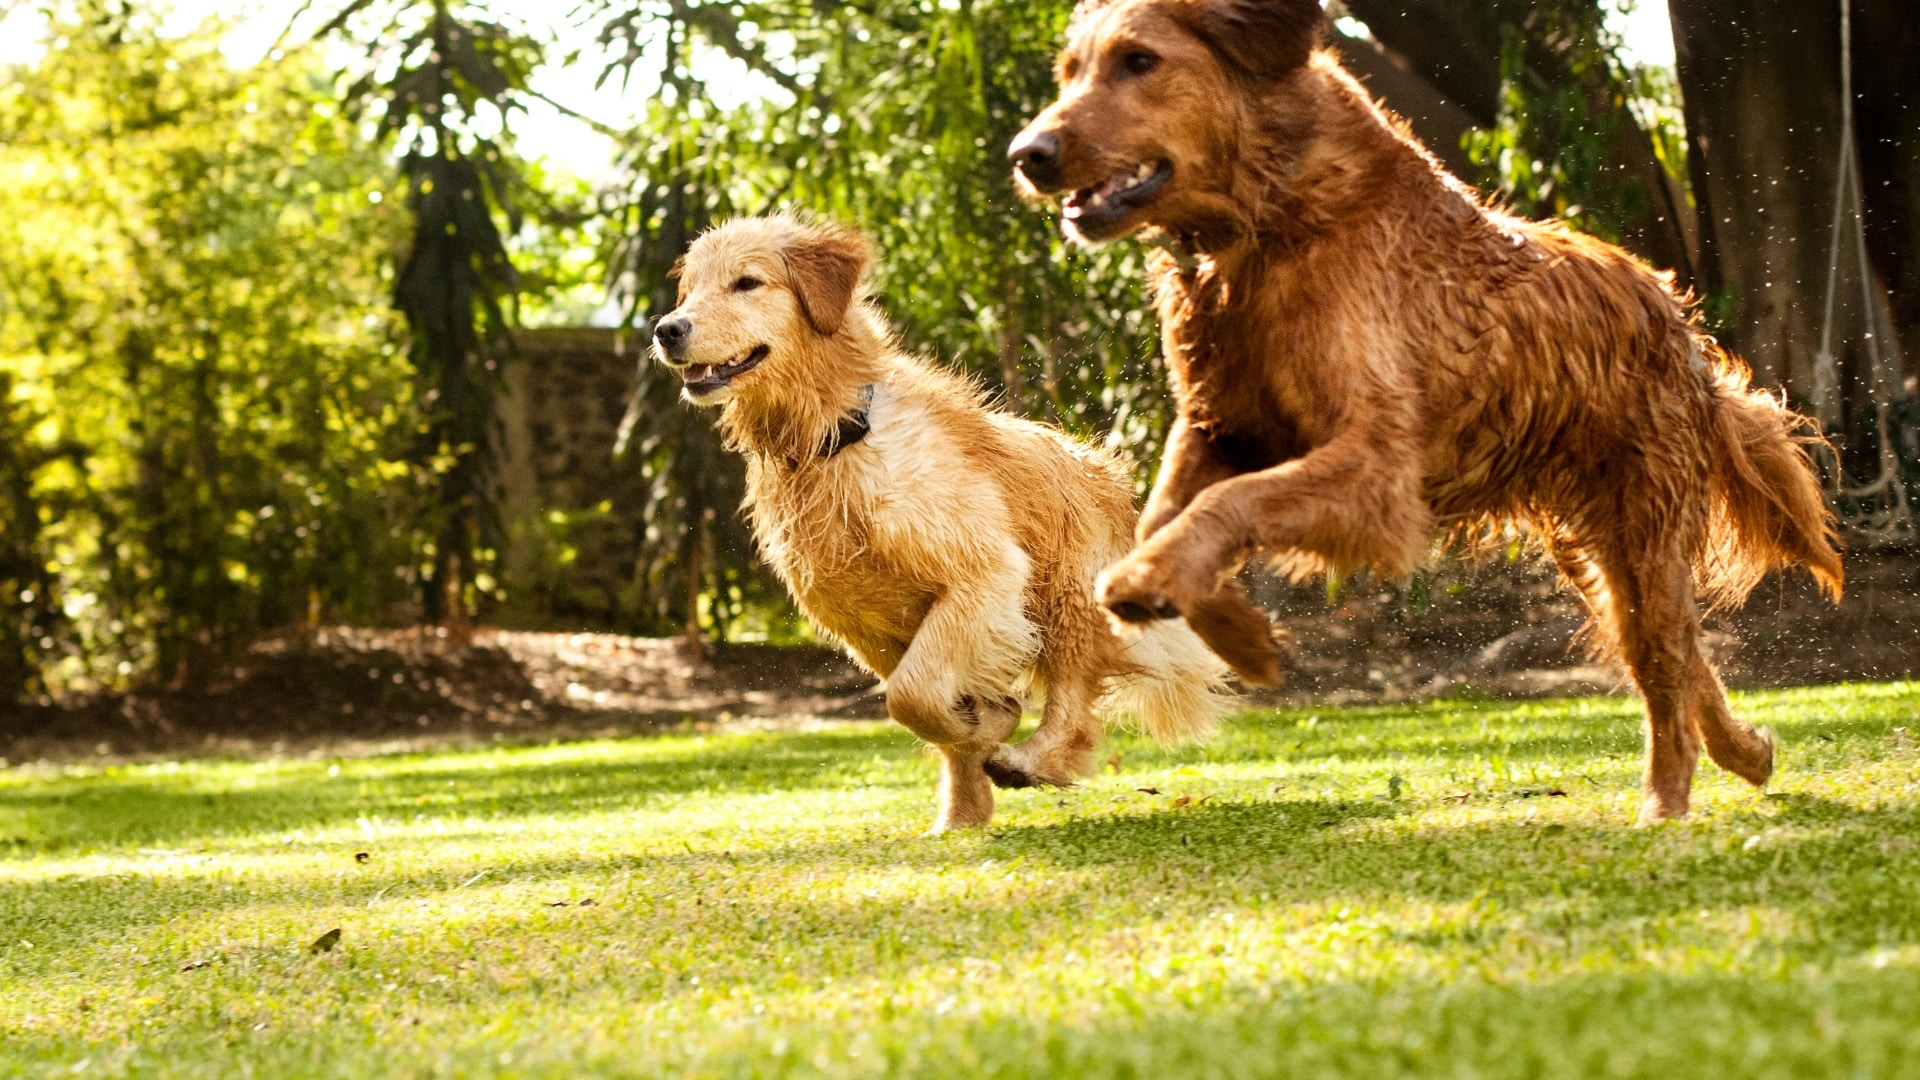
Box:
[1094,619,1235,744]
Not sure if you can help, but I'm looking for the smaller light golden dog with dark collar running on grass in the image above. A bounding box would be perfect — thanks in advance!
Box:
[653,215,1227,832]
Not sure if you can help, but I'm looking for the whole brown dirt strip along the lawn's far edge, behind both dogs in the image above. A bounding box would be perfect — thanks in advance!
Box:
[0,555,1920,761]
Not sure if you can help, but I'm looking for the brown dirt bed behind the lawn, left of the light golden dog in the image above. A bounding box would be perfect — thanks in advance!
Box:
[0,626,885,761]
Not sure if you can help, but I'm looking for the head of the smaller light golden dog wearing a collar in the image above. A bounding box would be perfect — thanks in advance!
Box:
[653,213,874,405]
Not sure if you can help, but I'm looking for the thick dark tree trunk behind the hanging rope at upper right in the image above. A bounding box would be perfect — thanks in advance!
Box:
[1668,0,1920,445]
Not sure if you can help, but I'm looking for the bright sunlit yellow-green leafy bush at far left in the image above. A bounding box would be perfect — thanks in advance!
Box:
[0,4,426,694]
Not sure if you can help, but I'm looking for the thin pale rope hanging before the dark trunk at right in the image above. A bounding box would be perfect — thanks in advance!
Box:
[1812,0,1914,546]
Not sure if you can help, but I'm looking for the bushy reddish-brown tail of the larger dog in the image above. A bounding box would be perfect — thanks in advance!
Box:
[1695,338,1845,607]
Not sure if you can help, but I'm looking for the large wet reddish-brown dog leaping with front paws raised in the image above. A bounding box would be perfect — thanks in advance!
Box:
[1010,0,1841,821]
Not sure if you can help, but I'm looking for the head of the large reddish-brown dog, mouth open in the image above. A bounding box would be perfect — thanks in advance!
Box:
[1008,0,1321,244]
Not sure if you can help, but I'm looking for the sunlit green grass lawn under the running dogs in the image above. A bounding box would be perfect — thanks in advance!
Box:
[0,682,1920,1078]
